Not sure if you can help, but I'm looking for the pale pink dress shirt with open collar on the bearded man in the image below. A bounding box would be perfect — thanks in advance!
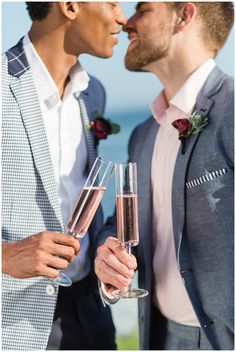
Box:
[151,59,215,326]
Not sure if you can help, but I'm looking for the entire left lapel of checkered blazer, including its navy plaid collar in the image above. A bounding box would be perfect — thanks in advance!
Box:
[6,38,63,228]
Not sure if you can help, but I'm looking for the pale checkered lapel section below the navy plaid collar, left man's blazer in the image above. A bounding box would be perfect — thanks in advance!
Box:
[10,70,62,225]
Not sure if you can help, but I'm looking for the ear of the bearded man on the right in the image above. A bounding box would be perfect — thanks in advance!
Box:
[175,2,197,32]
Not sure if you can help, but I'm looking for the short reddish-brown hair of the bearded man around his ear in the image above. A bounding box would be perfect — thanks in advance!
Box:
[168,1,234,55]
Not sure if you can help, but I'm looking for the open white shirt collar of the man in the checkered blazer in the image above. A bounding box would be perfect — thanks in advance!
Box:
[23,34,89,109]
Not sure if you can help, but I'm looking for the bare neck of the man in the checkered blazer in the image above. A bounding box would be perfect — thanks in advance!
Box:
[29,7,77,97]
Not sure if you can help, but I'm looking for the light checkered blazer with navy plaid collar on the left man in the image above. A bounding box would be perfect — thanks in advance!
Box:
[2,40,105,350]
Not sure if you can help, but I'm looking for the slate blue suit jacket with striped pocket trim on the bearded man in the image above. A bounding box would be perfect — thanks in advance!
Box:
[129,67,234,349]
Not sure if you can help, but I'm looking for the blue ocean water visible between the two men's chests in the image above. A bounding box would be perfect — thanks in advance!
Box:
[99,108,151,219]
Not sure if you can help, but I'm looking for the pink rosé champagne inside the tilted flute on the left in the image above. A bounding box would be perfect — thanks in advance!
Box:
[67,187,106,238]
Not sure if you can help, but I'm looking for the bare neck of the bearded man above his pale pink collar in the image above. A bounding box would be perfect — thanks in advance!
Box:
[144,26,214,101]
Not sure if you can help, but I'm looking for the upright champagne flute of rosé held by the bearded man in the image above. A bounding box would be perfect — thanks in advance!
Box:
[113,163,148,298]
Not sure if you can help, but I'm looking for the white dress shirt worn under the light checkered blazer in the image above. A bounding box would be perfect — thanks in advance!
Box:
[23,34,91,281]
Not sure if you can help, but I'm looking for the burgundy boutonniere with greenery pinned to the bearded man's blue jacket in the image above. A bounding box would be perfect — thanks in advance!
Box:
[172,111,208,154]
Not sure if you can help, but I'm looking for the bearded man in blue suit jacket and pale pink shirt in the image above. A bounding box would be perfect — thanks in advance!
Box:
[96,2,234,350]
